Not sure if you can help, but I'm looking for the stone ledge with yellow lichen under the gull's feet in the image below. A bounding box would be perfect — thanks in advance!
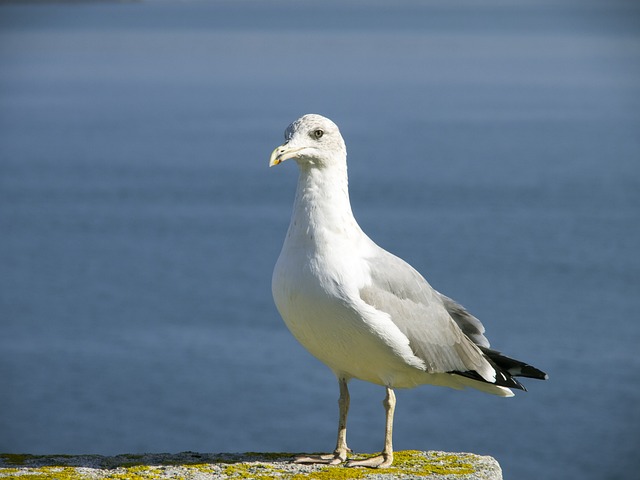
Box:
[0,450,502,480]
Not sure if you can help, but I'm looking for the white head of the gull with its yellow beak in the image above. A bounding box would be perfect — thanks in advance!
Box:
[269,113,347,168]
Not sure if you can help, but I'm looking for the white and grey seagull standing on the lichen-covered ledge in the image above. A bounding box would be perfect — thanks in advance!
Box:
[269,114,548,468]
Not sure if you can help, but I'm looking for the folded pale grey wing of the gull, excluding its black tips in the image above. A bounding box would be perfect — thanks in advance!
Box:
[360,249,495,381]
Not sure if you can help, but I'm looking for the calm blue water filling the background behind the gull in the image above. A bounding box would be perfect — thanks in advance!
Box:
[0,0,640,480]
